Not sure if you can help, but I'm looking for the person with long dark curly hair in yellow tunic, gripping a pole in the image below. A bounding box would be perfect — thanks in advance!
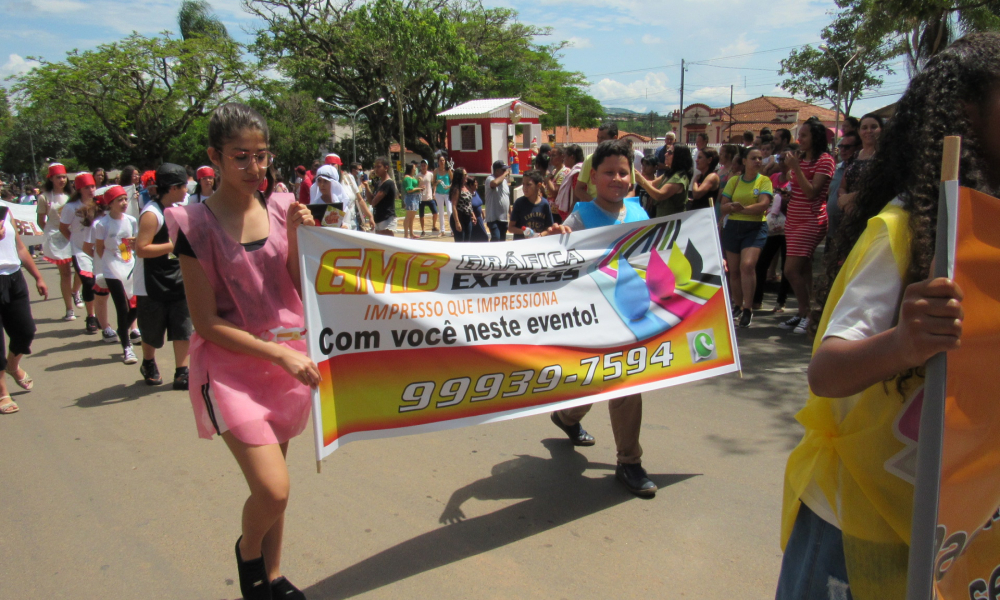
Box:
[776,33,1000,600]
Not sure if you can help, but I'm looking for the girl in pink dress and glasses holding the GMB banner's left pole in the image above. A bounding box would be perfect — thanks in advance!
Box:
[165,103,319,600]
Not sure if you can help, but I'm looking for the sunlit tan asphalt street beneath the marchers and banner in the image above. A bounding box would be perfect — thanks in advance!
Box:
[0,265,809,600]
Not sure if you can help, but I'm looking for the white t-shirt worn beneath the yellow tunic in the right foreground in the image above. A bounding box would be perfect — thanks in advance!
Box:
[801,200,904,528]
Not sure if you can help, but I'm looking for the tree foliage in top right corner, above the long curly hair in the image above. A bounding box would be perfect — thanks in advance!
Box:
[838,0,1000,73]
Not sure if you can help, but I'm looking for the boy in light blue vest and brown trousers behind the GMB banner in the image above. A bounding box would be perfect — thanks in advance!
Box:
[550,140,656,497]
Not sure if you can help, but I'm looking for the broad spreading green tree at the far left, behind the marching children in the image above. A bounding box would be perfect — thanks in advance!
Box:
[13,34,260,166]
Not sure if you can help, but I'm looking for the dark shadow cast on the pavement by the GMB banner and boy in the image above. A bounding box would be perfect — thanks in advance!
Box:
[303,439,696,600]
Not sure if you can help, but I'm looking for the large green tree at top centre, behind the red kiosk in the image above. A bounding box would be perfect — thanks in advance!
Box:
[243,0,597,157]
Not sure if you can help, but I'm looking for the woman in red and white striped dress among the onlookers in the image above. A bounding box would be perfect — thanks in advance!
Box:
[778,120,837,333]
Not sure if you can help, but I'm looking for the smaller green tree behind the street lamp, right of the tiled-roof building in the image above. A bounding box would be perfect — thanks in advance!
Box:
[779,11,895,115]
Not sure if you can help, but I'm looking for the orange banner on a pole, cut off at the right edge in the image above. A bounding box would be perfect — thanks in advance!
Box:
[932,188,1000,600]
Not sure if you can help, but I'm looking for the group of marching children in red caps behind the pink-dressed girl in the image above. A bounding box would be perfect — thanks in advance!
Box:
[38,163,191,390]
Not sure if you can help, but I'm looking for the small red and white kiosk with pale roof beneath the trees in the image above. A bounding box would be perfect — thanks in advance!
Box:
[438,98,545,174]
